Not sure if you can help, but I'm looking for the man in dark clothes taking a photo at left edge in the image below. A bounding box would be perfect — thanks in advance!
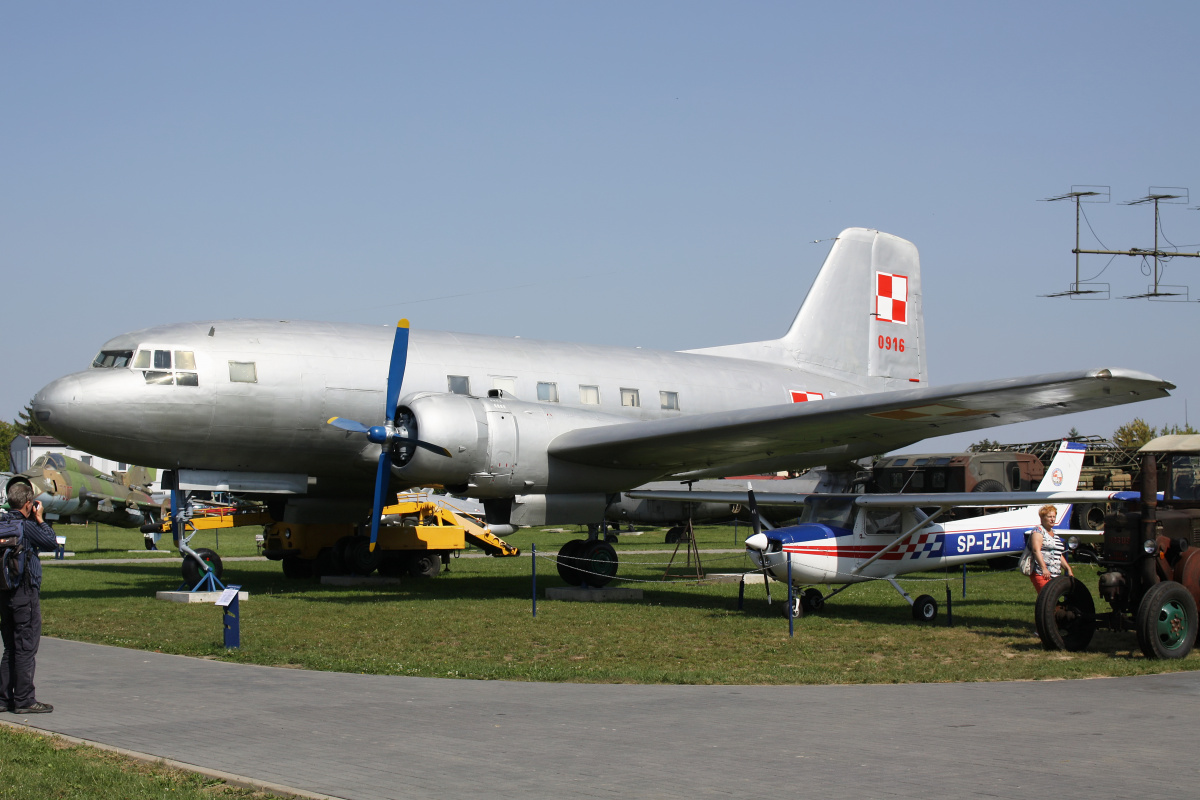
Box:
[0,483,55,714]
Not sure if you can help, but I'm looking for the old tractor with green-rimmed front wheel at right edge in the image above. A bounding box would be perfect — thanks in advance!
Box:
[1034,435,1200,658]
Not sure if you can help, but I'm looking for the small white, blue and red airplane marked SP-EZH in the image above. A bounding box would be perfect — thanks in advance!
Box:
[629,441,1136,621]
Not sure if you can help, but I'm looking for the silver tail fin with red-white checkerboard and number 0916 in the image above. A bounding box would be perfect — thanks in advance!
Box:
[691,228,929,391]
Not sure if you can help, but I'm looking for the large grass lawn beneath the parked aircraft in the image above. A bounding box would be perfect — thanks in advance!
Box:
[42,527,1200,684]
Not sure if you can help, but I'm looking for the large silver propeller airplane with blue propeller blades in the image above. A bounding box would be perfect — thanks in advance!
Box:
[32,228,1174,578]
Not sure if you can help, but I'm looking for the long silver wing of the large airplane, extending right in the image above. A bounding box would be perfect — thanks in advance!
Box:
[550,369,1175,477]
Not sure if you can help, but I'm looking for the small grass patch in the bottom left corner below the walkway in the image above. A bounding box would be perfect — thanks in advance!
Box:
[0,726,288,800]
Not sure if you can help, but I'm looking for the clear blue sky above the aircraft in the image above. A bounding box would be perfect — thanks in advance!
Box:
[0,0,1200,449]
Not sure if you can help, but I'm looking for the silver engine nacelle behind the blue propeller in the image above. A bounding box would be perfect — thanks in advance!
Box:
[392,392,654,499]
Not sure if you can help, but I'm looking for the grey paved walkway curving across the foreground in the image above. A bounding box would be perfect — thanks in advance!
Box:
[11,639,1200,800]
